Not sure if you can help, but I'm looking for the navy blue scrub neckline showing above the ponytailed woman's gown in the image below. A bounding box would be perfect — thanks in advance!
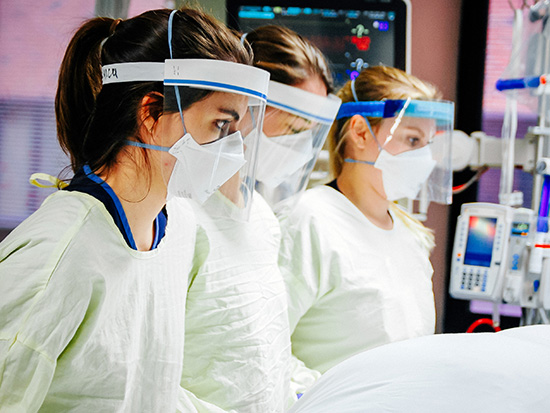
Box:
[64,165,167,250]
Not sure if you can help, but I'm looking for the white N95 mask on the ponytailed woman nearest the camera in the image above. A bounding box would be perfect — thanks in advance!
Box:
[166,131,246,204]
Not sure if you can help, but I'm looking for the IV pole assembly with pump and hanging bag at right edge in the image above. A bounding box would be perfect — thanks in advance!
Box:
[449,0,550,326]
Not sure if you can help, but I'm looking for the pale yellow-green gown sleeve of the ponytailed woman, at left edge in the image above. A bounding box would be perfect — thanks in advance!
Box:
[0,217,93,412]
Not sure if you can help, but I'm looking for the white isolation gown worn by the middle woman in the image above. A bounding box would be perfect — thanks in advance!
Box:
[182,192,291,413]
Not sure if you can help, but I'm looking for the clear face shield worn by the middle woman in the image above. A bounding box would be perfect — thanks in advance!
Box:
[245,81,341,214]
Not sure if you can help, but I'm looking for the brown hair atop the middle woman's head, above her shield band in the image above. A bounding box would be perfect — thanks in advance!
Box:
[246,25,333,93]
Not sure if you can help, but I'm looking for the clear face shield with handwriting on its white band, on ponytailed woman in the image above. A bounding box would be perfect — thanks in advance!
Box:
[103,59,269,220]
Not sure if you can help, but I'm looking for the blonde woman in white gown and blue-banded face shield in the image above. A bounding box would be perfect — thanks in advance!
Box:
[279,66,454,372]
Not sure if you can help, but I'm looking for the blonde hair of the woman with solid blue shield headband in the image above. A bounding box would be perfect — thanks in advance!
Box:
[327,66,441,178]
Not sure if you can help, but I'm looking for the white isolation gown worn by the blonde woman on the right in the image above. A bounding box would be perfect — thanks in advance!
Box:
[279,185,435,373]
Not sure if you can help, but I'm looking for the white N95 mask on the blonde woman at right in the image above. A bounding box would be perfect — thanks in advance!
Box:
[374,145,436,201]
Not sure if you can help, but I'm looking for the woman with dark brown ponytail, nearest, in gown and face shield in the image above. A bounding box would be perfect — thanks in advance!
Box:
[0,8,269,412]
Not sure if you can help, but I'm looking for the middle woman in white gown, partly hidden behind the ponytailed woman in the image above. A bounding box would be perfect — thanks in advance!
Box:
[182,26,340,412]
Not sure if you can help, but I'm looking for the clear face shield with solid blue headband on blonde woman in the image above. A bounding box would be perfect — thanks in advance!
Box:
[338,99,454,204]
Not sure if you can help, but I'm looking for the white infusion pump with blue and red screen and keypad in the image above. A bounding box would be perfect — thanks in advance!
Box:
[449,202,534,303]
